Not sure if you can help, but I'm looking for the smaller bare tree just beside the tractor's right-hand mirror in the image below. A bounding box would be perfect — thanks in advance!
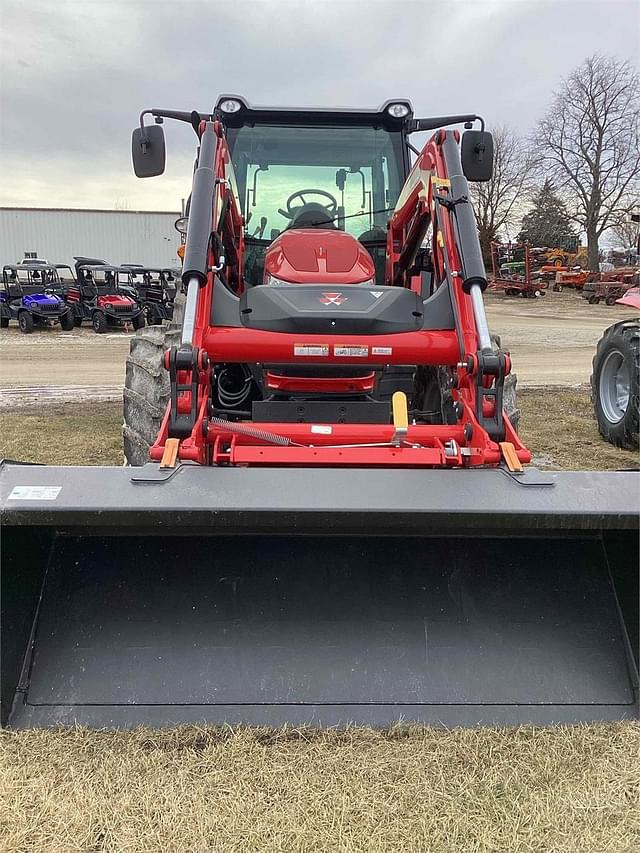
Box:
[471,125,534,260]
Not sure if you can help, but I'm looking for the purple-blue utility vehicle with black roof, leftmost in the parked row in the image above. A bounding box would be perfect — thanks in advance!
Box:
[0,263,74,335]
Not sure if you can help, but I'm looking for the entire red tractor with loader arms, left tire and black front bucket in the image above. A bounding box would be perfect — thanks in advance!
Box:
[0,96,640,727]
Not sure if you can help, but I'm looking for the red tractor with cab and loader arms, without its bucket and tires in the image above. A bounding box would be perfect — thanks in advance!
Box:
[125,97,531,470]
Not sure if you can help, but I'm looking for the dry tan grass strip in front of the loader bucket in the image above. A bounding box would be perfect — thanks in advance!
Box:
[0,723,640,853]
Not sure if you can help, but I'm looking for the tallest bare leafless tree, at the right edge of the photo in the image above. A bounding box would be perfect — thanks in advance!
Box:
[536,54,640,271]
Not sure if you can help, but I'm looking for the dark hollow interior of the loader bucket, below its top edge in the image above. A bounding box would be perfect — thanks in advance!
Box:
[2,528,638,727]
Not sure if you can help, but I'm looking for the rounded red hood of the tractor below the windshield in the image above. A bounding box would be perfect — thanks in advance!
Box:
[264,228,375,284]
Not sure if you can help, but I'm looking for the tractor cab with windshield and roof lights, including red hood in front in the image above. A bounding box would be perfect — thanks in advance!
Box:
[214,96,412,287]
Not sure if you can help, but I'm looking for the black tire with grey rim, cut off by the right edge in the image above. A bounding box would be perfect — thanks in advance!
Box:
[591,319,640,450]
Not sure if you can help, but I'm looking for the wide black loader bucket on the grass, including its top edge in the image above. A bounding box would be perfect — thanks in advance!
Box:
[0,464,639,727]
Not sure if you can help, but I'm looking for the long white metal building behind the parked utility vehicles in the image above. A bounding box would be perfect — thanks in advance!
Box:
[0,207,180,267]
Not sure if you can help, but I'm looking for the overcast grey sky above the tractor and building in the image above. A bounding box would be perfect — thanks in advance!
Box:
[0,0,640,210]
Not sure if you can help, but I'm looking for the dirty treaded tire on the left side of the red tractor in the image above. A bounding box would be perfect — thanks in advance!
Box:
[122,293,185,465]
